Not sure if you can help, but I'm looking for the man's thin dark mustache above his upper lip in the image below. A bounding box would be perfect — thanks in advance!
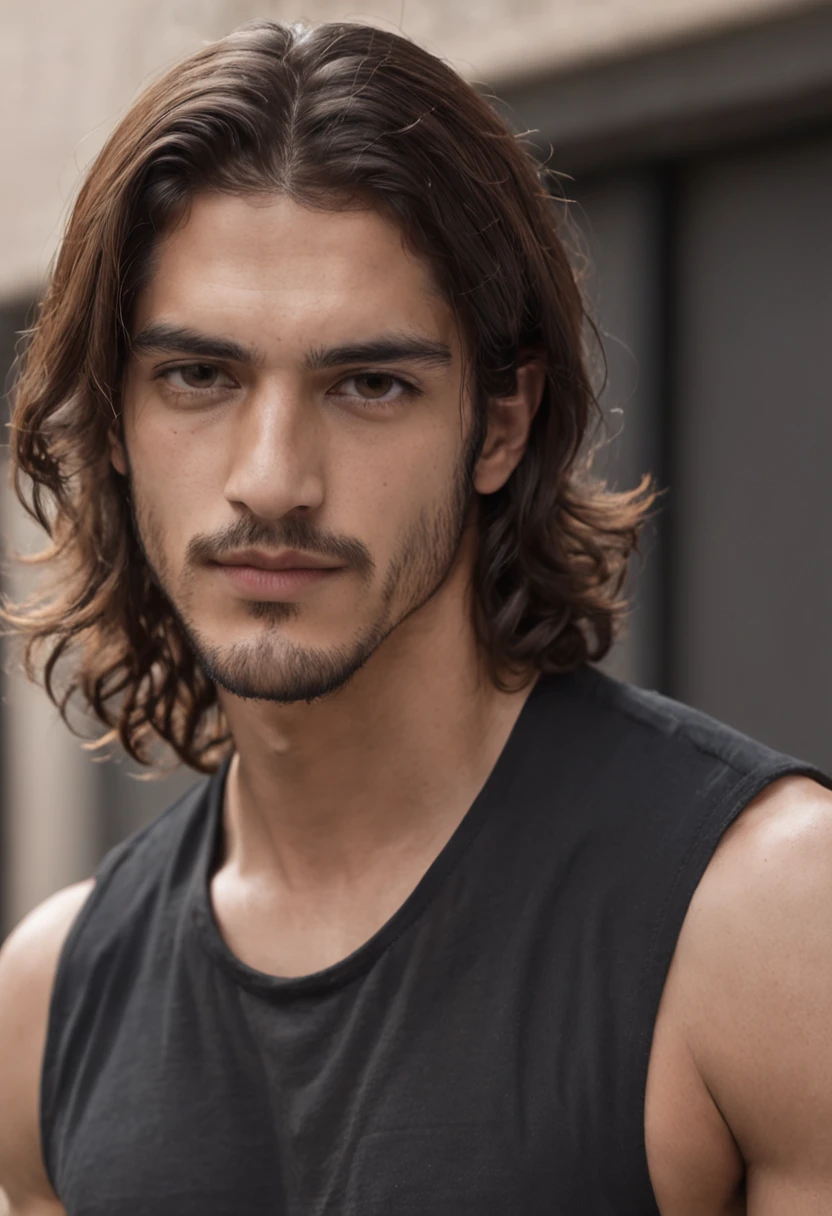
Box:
[185,516,376,576]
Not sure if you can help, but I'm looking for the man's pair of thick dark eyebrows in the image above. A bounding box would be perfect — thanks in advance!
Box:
[130,321,452,371]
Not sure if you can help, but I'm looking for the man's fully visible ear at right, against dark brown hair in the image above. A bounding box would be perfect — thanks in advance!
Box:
[473,358,546,494]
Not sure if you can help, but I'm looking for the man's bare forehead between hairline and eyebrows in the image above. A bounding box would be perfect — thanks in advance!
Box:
[134,195,455,349]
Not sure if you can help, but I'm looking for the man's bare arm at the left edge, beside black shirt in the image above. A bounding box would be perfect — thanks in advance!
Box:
[0,880,92,1216]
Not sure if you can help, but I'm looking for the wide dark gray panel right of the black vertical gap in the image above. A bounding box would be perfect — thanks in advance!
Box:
[674,135,832,767]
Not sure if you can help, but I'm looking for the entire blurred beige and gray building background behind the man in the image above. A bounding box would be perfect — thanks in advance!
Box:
[0,0,832,934]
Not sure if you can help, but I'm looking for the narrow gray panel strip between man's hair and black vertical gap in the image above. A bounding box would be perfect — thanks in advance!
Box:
[575,170,662,686]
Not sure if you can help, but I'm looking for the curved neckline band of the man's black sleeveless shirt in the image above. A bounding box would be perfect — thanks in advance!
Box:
[191,674,552,1001]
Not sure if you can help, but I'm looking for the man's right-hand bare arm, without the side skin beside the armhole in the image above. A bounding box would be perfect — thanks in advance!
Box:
[669,778,832,1216]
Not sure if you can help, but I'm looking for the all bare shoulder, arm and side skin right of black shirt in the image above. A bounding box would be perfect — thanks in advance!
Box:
[646,777,832,1216]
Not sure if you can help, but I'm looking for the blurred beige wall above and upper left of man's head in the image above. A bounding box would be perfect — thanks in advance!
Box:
[0,0,817,300]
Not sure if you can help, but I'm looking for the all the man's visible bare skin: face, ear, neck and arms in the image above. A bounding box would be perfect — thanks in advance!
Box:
[0,196,832,1216]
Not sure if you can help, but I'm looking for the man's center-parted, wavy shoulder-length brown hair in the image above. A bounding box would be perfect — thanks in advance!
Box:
[5,21,652,771]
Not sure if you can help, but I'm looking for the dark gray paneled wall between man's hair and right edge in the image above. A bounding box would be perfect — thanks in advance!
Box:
[575,131,832,769]
